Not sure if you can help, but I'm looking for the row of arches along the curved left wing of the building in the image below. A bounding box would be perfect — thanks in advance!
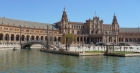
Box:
[0,33,61,43]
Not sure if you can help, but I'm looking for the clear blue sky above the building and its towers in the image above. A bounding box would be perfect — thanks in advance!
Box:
[0,0,140,28]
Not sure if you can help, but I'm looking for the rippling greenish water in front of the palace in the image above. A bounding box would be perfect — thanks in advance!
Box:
[0,49,140,73]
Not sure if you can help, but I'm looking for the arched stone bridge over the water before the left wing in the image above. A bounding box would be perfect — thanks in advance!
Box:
[21,41,49,49]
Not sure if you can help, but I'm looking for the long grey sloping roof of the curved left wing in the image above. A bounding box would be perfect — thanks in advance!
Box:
[0,17,57,30]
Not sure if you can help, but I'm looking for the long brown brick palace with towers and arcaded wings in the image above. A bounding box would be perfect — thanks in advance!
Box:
[0,8,140,44]
